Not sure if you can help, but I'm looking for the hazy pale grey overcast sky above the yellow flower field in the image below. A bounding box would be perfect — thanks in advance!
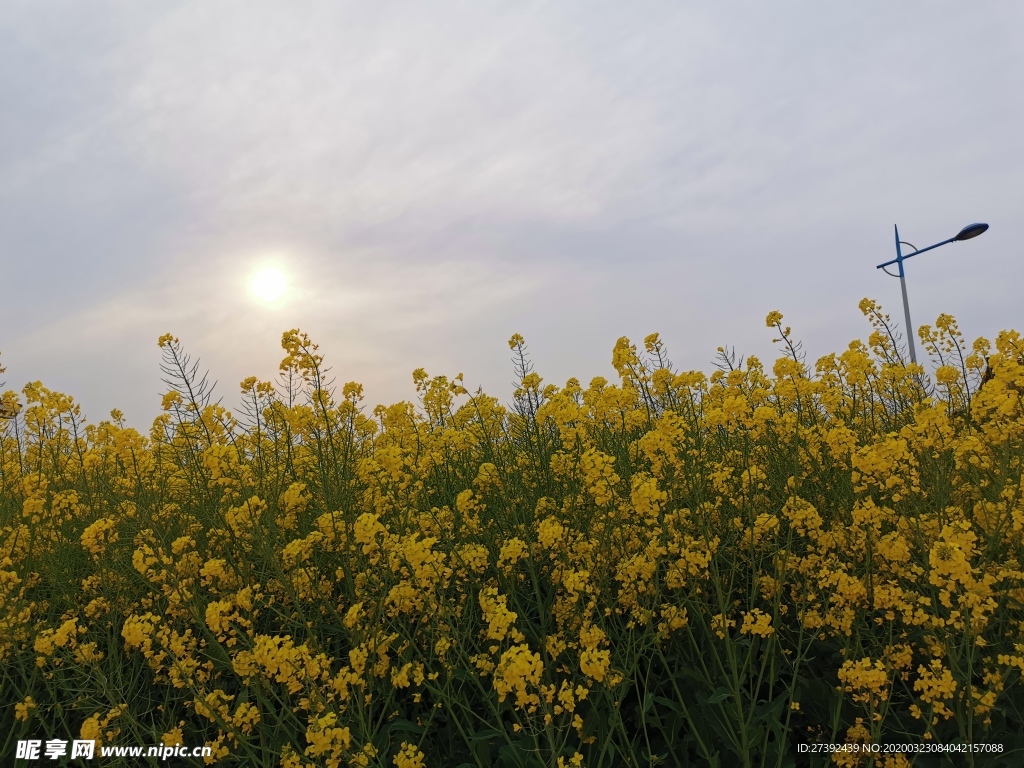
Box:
[0,0,1024,430]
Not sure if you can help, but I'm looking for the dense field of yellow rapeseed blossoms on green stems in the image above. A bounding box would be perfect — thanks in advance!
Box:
[0,299,1024,768]
